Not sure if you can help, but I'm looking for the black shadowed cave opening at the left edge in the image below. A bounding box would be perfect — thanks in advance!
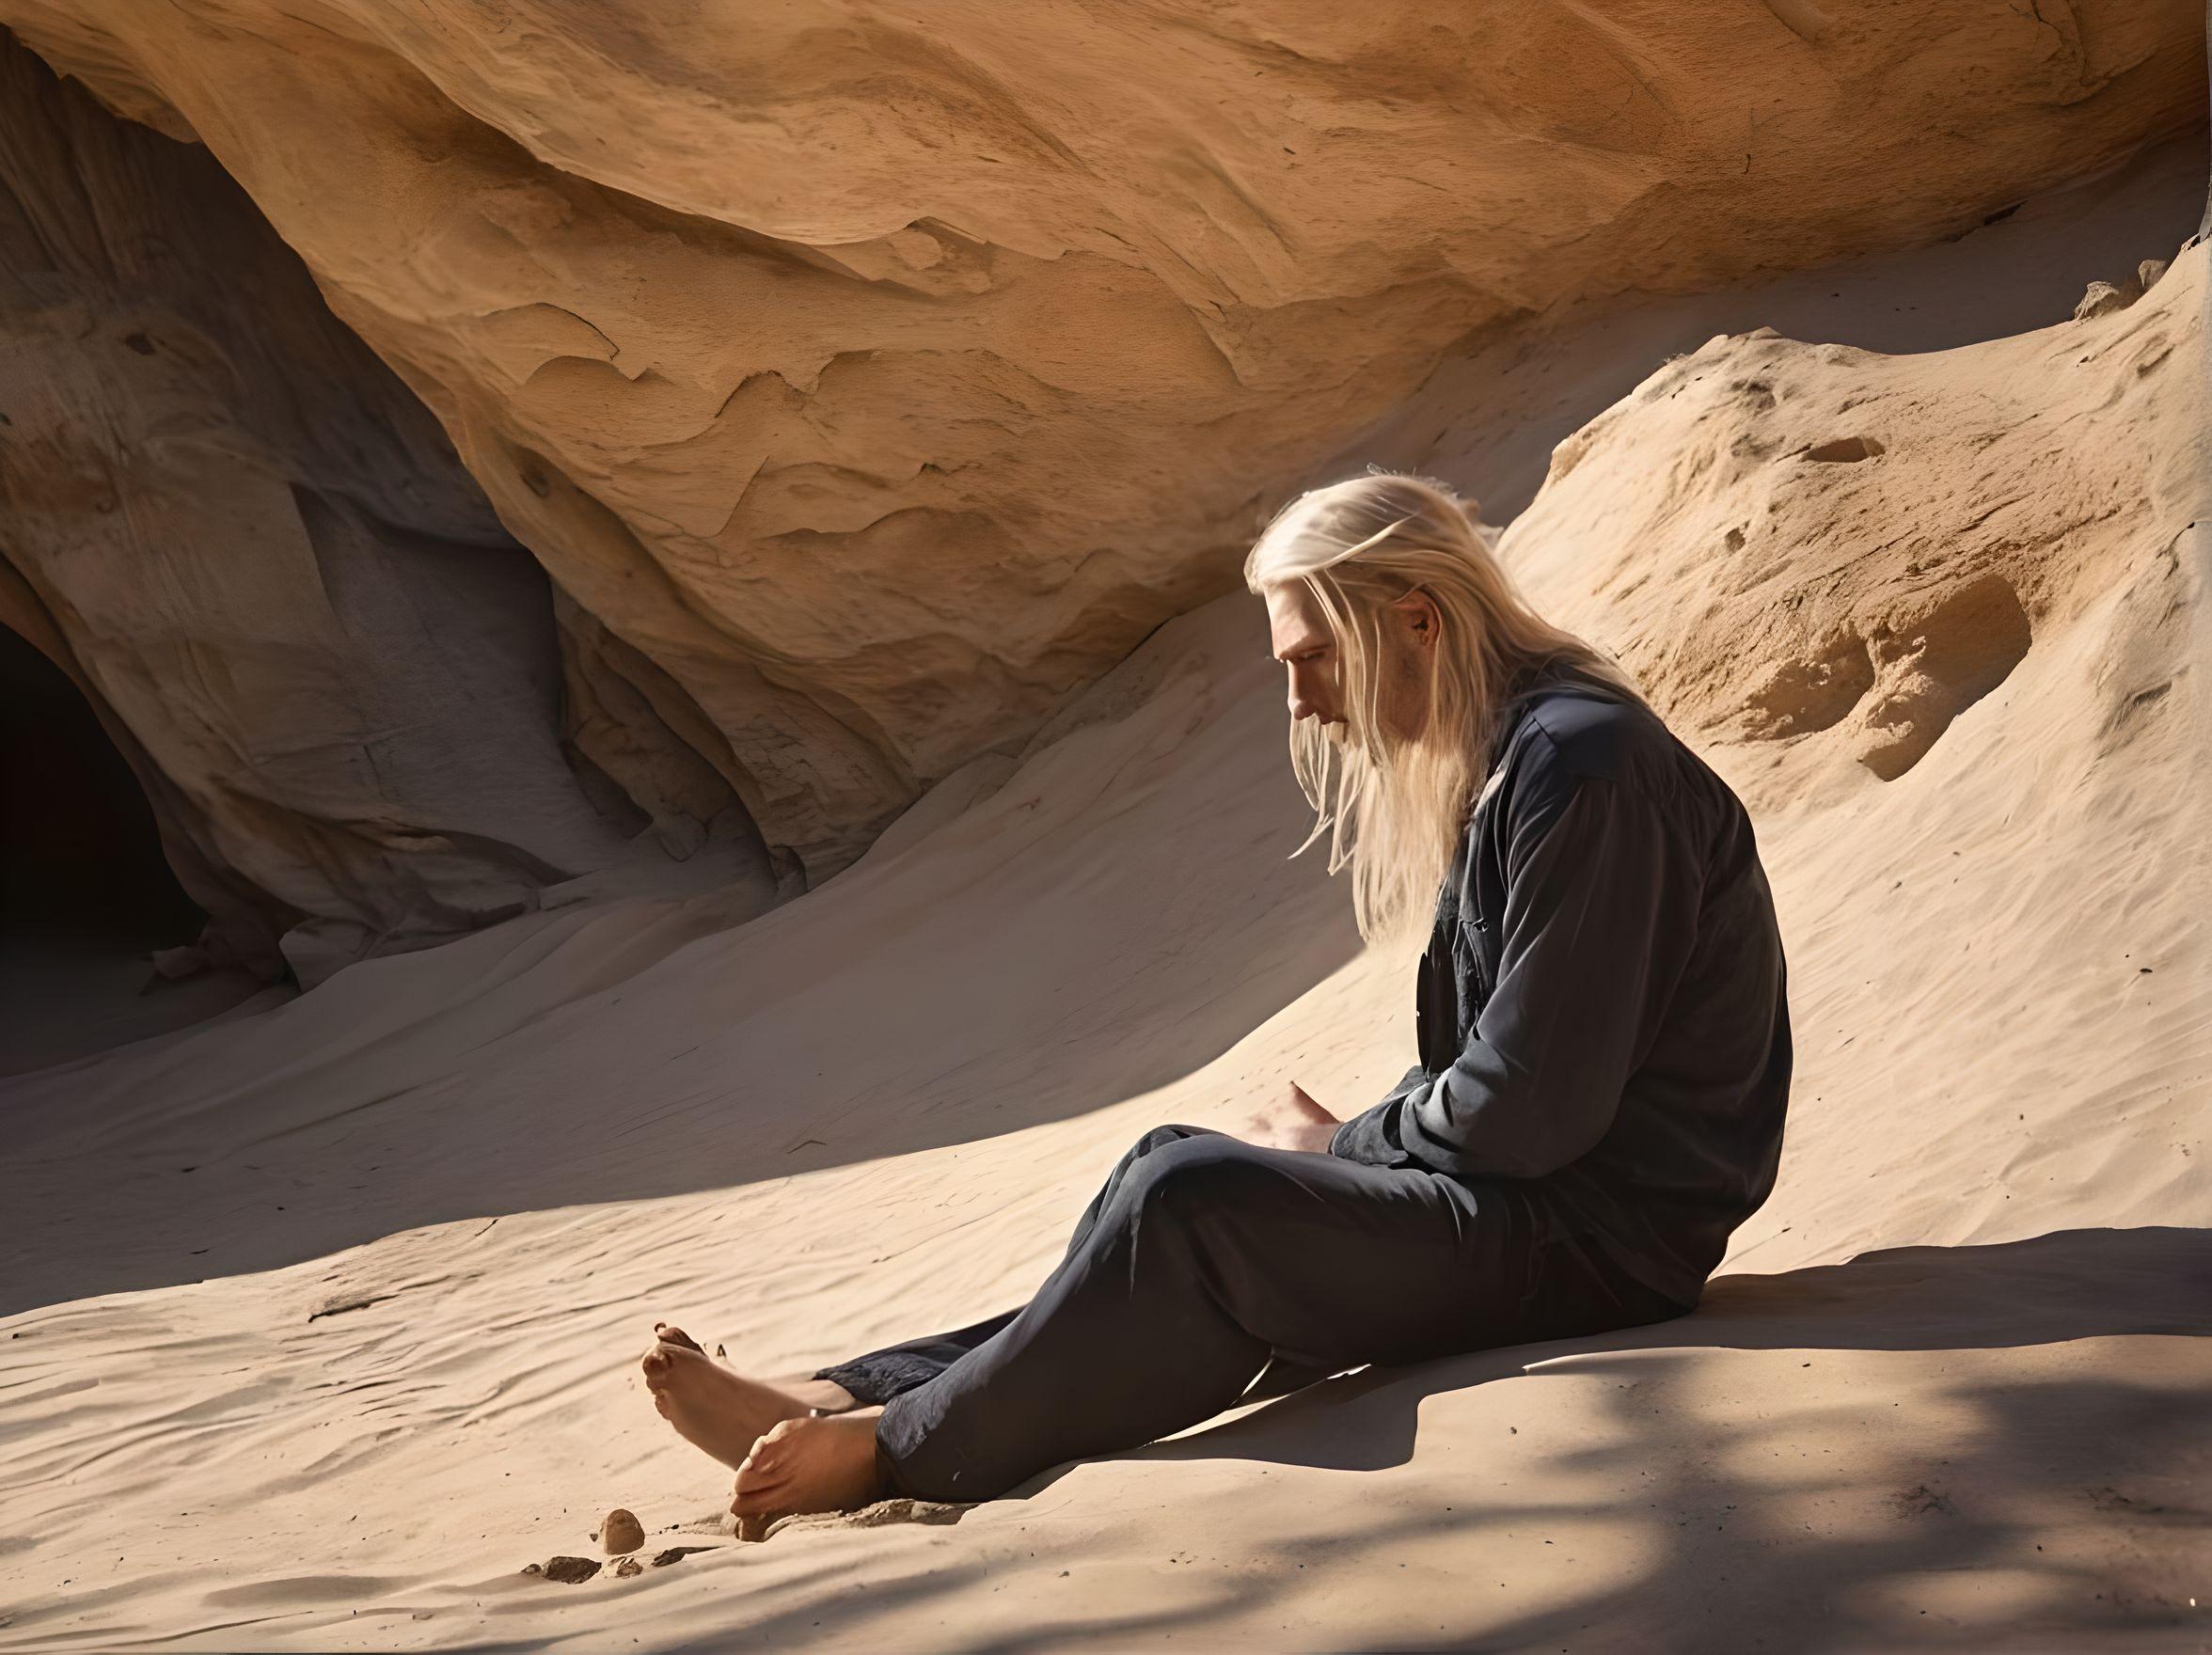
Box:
[0,626,257,1073]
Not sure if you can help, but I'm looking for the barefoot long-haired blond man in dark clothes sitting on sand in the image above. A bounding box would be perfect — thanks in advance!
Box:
[643,471,1792,1522]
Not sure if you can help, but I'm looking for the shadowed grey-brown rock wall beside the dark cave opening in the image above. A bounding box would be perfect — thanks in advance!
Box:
[0,38,761,983]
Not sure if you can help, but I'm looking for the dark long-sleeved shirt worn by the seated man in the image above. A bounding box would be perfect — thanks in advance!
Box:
[1330,669,1790,1308]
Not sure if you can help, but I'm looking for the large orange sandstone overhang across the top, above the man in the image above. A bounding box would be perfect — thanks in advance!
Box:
[0,0,2204,880]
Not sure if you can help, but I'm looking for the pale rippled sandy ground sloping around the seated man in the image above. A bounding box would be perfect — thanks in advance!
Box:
[0,142,2212,1653]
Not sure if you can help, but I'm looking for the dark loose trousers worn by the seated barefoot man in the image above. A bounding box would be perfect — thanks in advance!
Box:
[818,1127,1683,1500]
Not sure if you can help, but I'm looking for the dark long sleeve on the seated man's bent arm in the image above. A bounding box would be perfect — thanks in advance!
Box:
[1330,777,1701,1177]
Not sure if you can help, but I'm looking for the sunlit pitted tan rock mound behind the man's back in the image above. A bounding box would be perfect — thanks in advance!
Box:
[1500,259,2212,814]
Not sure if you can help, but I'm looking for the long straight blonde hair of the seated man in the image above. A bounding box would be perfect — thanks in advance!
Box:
[1245,466,1644,940]
